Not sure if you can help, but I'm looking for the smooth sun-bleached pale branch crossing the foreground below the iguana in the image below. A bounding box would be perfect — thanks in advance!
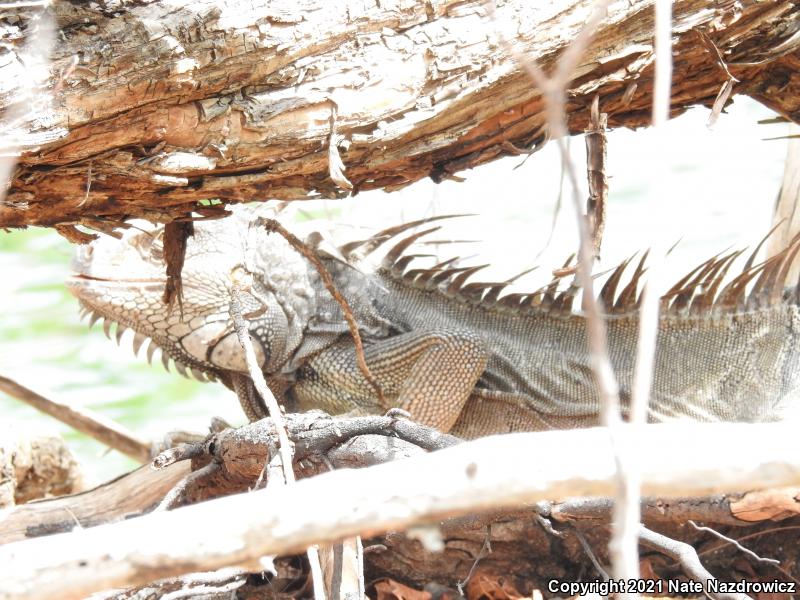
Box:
[0,423,800,600]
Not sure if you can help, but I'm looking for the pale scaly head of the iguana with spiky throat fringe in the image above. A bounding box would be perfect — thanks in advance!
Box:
[67,207,315,376]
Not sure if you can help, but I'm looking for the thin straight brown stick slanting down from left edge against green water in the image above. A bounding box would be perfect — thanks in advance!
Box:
[0,375,152,464]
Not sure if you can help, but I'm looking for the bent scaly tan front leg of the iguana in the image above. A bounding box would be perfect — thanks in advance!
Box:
[292,330,489,432]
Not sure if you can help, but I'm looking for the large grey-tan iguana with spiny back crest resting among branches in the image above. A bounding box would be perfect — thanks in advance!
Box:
[69,208,800,438]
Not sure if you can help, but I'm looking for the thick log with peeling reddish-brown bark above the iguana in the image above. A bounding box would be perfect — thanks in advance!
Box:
[0,0,800,230]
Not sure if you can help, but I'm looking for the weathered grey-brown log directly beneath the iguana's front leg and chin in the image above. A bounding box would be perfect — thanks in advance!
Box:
[0,415,432,544]
